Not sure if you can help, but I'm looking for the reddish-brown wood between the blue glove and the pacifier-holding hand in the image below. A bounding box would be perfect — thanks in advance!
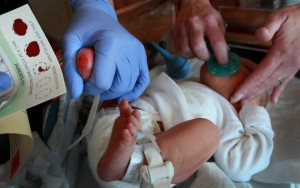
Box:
[116,0,175,44]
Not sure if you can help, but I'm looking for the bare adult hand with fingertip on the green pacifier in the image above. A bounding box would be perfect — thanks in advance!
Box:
[173,0,228,64]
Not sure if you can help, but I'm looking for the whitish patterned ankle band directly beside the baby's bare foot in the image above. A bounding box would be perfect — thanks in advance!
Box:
[121,145,144,183]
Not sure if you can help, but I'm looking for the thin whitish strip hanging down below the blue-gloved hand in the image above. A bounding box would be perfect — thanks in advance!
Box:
[67,95,100,150]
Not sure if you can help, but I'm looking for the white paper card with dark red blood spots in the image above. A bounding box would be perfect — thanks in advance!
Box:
[0,5,66,119]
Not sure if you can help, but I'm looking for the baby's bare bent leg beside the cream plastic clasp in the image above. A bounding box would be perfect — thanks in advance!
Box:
[156,118,219,183]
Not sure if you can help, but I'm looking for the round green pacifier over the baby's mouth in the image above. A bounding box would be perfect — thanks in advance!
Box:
[207,51,241,76]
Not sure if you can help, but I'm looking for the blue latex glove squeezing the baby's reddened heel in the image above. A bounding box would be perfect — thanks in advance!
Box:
[62,0,150,101]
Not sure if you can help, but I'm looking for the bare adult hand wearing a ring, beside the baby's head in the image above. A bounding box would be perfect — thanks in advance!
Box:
[231,4,300,103]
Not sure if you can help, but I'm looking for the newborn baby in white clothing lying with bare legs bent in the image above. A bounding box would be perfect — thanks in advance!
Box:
[88,51,274,187]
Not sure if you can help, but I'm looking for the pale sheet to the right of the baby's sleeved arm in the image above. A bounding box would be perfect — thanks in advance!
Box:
[254,78,300,184]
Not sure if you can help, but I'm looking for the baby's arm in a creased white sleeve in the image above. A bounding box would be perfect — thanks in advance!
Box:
[214,104,274,181]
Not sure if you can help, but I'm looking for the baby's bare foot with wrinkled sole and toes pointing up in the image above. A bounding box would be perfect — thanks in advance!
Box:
[97,100,141,181]
